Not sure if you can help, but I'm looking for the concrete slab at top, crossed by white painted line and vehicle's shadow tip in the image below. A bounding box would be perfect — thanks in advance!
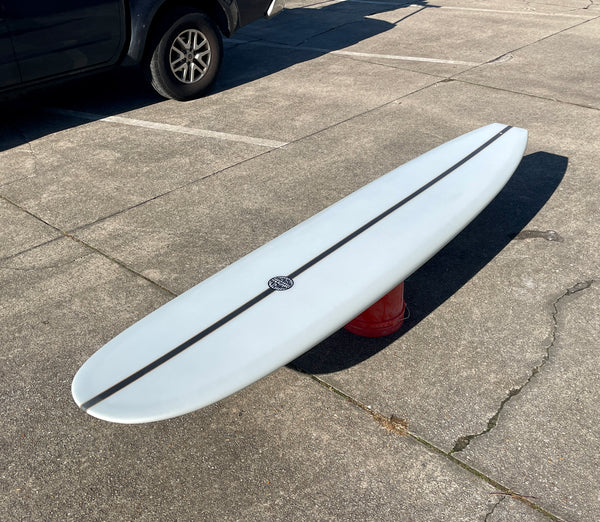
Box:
[236,1,593,76]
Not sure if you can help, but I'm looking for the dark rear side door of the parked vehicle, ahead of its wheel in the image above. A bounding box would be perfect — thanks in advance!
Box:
[3,0,125,82]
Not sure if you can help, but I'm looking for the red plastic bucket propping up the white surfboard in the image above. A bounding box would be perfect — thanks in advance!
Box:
[344,282,406,337]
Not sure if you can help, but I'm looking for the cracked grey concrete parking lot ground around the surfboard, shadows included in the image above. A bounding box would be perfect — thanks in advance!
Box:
[0,0,600,522]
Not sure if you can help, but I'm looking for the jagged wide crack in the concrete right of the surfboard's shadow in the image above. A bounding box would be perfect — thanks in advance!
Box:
[449,279,595,455]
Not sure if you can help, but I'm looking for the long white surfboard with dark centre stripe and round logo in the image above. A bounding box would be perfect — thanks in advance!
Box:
[72,124,527,423]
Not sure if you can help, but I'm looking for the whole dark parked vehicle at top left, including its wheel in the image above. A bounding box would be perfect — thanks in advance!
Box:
[0,0,283,100]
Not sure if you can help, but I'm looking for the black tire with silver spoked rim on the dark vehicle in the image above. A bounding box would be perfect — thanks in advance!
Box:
[147,10,223,101]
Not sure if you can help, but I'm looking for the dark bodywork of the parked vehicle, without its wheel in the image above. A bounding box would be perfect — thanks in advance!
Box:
[0,0,272,91]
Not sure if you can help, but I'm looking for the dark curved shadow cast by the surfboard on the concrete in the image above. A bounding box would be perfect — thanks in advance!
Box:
[288,152,568,374]
